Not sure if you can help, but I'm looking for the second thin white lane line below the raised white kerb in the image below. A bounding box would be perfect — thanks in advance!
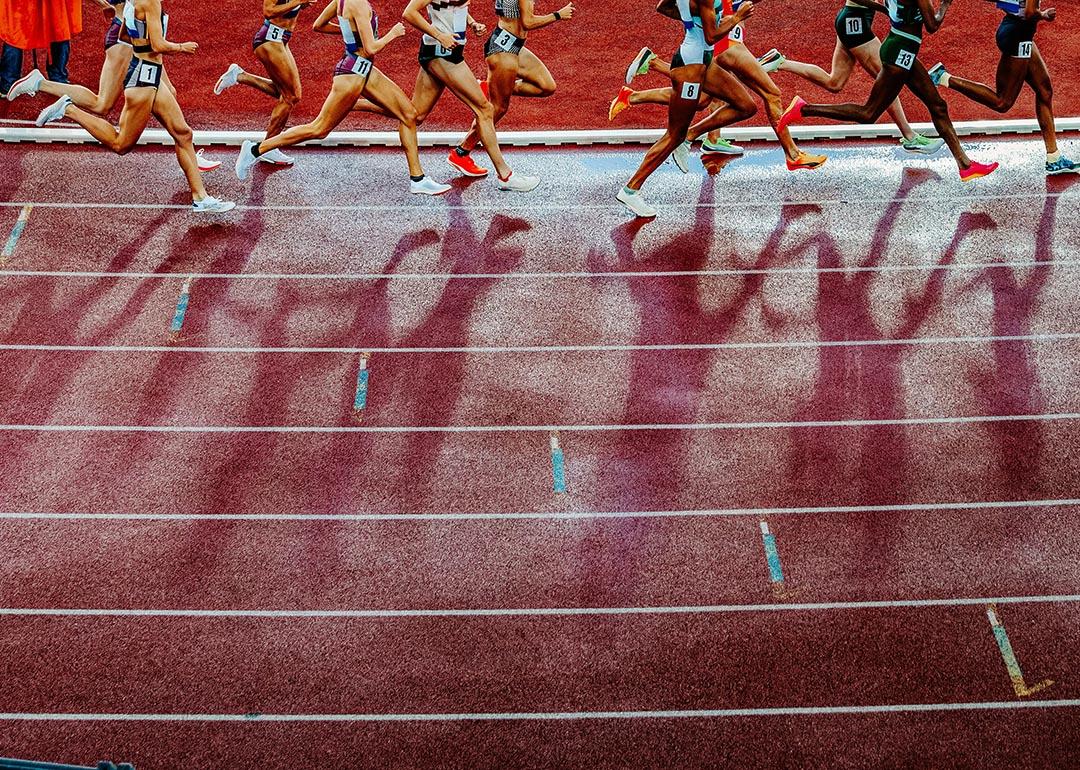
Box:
[0,259,1080,281]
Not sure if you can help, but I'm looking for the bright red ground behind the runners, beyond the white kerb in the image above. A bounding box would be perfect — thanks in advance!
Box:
[0,0,1080,130]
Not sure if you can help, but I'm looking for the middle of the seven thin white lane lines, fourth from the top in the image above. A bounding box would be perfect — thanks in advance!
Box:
[0,411,1080,434]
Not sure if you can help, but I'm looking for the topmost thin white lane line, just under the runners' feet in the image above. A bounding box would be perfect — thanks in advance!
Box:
[0,191,1080,212]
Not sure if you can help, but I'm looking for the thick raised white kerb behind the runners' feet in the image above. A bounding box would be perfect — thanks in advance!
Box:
[0,118,1080,147]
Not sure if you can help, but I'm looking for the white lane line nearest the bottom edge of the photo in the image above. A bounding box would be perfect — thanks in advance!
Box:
[0,699,1080,722]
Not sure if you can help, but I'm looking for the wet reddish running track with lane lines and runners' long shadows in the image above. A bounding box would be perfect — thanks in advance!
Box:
[0,141,1080,770]
